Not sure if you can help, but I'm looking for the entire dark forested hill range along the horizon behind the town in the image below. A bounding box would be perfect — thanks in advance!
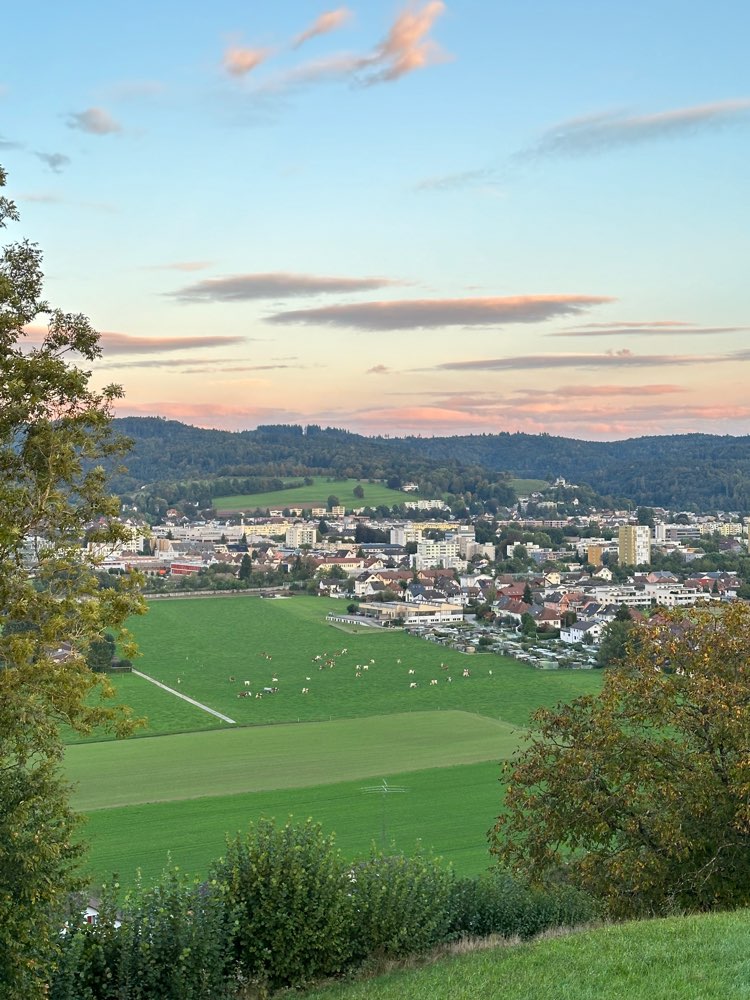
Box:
[115,417,750,512]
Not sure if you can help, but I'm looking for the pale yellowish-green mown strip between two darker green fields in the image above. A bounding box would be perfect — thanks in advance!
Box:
[65,712,520,811]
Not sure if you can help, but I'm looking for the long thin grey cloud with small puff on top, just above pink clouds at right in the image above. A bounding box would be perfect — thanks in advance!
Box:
[427,349,724,372]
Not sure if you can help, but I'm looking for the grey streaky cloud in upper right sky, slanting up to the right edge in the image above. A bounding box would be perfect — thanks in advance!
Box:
[521,97,750,156]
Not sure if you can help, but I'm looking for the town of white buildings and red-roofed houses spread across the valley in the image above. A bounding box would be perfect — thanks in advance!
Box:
[67,482,750,666]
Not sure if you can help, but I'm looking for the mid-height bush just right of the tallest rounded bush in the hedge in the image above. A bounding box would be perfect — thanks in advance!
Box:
[349,854,453,961]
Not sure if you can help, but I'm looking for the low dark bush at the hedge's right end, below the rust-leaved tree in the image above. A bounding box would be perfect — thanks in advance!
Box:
[450,870,597,938]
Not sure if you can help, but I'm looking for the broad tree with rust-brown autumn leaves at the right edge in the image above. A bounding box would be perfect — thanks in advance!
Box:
[491,603,750,916]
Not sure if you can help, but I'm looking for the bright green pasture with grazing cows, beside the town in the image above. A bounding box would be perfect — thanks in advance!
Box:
[104,597,601,733]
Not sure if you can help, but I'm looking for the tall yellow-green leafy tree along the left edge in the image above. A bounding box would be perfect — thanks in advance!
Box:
[0,169,142,1000]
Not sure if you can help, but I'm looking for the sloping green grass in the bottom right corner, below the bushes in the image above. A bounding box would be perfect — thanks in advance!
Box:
[305,910,750,1000]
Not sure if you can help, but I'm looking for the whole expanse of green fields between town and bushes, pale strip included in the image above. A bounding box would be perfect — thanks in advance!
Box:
[66,597,600,884]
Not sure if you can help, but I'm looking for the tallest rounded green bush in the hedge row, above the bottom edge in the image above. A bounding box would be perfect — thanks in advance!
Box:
[212,819,352,989]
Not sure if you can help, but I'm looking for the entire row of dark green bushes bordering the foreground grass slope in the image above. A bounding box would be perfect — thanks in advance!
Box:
[48,820,596,1000]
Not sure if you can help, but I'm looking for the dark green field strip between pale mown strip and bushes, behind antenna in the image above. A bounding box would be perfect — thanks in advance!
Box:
[83,760,502,885]
